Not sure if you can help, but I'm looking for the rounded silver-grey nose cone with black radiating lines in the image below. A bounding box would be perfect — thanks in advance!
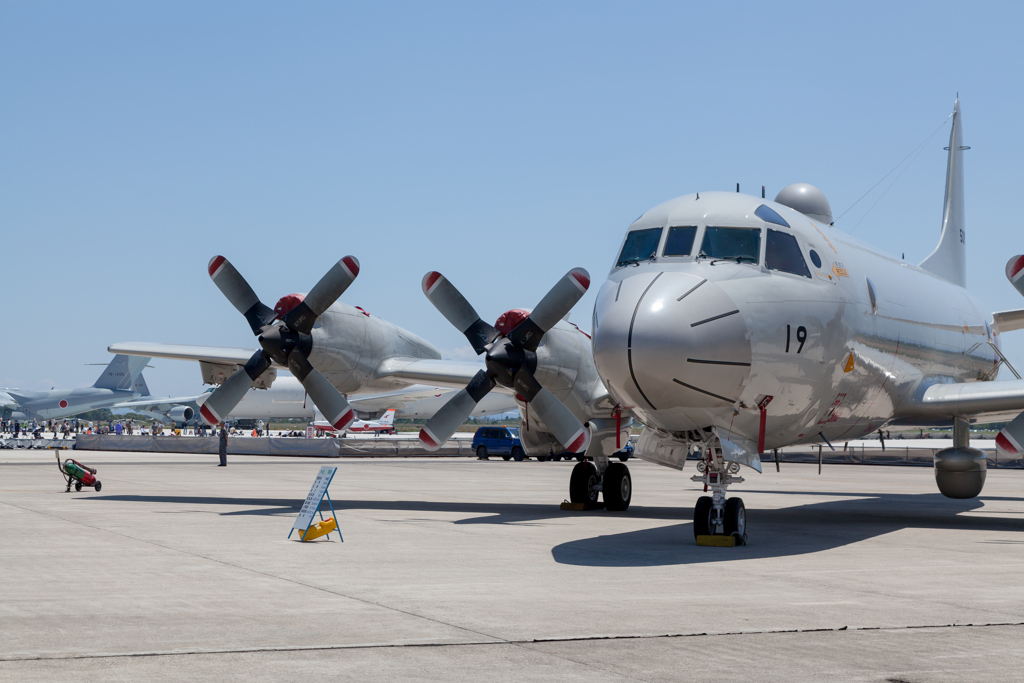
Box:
[594,272,751,417]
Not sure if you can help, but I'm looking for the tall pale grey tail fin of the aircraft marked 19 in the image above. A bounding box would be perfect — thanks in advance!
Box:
[921,97,970,287]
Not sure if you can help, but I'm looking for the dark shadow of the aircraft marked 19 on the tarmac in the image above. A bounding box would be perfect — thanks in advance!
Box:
[82,490,1024,567]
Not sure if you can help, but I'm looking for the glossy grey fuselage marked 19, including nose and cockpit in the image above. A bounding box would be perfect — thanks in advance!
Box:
[593,193,996,449]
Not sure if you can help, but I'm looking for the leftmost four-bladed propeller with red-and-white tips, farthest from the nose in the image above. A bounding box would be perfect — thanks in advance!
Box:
[200,256,359,429]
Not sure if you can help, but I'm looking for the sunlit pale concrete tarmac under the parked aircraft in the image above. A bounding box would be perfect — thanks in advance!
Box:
[0,451,1024,682]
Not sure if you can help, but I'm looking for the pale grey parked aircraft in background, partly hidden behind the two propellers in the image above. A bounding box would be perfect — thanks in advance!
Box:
[114,375,518,424]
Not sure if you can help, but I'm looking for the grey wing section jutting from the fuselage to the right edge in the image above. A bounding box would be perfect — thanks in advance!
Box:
[897,380,1024,423]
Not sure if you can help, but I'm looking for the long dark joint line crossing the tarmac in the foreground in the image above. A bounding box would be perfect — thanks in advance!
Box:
[0,622,1024,664]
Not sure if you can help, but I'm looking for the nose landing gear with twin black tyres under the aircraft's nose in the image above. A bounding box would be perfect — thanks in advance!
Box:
[690,447,746,546]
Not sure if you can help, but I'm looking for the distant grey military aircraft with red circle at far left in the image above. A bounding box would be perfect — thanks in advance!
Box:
[0,354,150,420]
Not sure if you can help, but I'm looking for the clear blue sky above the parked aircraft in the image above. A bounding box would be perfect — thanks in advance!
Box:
[0,2,1024,394]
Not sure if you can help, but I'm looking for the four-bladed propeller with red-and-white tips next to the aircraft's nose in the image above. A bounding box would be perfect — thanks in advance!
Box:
[420,268,590,453]
